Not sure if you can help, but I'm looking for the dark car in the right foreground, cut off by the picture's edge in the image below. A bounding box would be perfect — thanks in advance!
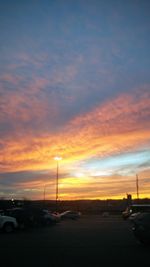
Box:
[132,212,150,245]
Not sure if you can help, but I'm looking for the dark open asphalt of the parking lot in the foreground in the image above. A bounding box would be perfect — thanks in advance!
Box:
[0,215,150,267]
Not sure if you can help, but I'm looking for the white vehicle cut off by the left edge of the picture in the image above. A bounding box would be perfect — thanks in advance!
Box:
[0,215,18,233]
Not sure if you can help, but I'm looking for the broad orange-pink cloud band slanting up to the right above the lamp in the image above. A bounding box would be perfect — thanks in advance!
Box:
[1,86,150,170]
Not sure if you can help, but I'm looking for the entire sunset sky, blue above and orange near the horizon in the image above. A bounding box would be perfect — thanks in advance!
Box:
[0,0,150,200]
